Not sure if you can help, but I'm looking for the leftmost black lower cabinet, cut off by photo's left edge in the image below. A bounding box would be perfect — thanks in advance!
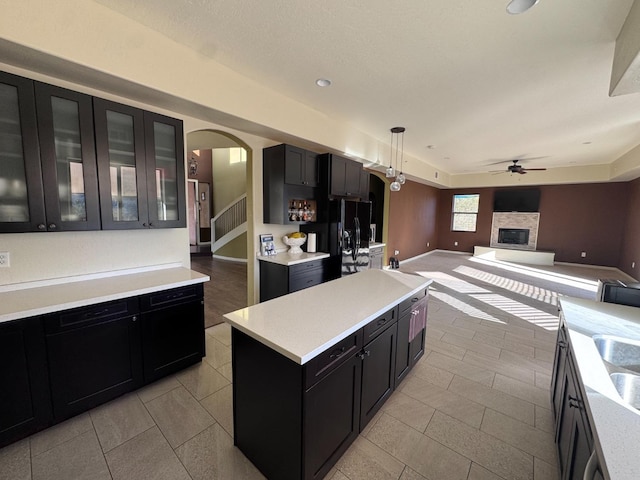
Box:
[0,318,51,448]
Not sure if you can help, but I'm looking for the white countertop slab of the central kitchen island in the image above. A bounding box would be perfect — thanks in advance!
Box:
[224,269,431,365]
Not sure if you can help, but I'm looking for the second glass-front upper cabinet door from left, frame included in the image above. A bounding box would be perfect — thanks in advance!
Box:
[35,82,100,231]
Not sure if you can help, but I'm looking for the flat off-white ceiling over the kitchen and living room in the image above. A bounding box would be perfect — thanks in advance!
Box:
[96,0,640,174]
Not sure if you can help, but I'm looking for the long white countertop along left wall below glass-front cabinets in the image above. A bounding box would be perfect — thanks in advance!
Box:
[0,267,209,323]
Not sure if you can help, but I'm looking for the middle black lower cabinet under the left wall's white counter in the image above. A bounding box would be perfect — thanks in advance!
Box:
[44,299,142,421]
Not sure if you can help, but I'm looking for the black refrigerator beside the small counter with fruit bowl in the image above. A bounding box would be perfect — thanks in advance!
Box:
[301,199,371,276]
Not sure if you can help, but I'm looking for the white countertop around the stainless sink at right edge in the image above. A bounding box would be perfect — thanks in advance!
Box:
[560,297,640,480]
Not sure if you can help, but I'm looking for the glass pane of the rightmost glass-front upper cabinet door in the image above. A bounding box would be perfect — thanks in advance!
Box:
[153,122,179,221]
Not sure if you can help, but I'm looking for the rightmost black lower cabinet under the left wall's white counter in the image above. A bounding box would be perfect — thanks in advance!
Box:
[140,284,205,383]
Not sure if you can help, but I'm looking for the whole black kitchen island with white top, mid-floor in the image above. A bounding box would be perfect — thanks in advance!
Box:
[225,270,431,480]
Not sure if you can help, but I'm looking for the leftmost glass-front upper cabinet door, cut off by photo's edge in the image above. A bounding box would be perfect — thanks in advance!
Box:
[0,72,46,232]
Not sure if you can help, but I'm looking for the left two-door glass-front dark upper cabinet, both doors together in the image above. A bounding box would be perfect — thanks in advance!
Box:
[0,72,100,233]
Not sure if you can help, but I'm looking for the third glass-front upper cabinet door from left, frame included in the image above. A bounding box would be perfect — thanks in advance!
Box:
[93,98,149,229]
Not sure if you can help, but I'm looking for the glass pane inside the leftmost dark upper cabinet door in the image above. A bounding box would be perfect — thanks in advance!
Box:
[0,83,30,222]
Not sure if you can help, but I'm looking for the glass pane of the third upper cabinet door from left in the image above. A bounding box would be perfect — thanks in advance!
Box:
[107,110,140,222]
